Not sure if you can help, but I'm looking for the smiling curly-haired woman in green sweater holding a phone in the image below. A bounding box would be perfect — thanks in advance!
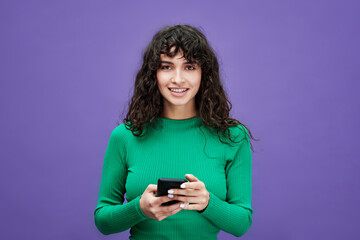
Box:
[94,25,257,240]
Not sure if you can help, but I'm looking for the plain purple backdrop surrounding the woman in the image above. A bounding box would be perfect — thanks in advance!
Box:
[0,0,360,240]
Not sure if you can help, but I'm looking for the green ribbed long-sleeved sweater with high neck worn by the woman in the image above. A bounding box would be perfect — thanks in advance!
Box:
[94,116,253,240]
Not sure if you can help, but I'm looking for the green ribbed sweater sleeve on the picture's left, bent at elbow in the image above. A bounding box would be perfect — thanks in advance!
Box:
[94,125,150,235]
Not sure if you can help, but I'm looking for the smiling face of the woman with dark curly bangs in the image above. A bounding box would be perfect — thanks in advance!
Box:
[156,50,201,114]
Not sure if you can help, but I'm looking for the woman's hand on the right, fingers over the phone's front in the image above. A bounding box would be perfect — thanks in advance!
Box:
[168,174,210,211]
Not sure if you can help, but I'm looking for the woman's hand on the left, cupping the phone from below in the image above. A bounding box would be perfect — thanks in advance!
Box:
[140,184,184,221]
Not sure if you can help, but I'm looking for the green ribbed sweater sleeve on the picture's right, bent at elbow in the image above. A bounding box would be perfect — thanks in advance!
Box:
[199,127,253,237]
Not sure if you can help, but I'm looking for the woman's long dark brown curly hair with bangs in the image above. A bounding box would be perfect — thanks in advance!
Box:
[117,25,259,150]
